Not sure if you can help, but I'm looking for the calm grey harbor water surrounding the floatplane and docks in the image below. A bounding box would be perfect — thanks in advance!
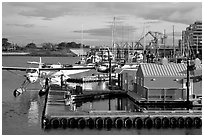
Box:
[2,56,202,135]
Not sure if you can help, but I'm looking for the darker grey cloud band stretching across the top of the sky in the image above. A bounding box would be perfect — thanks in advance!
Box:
[3,2,202,24]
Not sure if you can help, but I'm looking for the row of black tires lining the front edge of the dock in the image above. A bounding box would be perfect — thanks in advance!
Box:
[42,117,202,129]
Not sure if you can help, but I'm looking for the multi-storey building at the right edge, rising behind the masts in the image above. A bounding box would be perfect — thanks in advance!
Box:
[182,21,202,55]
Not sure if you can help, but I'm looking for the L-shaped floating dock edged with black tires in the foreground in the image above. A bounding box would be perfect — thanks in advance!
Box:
[42,86,202,130]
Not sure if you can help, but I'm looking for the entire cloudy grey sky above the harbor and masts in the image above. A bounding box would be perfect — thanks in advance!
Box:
[2,2,202,46]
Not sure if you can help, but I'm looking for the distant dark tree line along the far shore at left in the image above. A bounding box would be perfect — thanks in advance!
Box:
[2,38,90,52]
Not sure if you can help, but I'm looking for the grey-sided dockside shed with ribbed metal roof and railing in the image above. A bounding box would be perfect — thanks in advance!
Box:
[135,60,202,101]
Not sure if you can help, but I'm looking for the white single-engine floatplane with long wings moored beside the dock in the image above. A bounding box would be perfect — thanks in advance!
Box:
[2,57,95,97]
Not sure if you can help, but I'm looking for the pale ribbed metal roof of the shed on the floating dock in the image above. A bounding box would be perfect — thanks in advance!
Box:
[139,63,202,77]
